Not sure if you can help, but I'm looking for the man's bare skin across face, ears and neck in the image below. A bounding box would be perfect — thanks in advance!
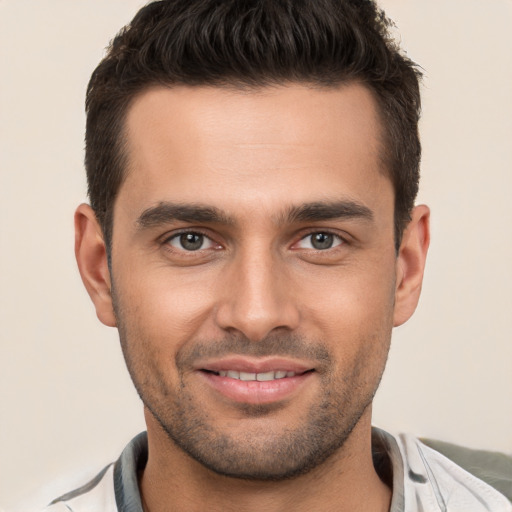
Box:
[76,84,429,512]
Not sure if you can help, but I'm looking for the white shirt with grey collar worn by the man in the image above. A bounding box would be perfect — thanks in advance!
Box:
[44,428,512,512]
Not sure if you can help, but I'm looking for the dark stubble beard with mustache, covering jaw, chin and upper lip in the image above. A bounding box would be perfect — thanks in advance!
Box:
[116,313,390,481]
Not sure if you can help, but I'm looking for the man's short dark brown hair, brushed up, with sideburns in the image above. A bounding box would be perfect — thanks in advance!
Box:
[85,0,421,248]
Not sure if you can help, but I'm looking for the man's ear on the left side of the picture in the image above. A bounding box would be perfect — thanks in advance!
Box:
[75,204,116,327]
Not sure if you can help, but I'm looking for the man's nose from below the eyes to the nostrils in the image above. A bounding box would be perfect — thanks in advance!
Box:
[216,247,300,341]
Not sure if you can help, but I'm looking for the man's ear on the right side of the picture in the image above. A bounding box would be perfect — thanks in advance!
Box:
[393,205,430,327]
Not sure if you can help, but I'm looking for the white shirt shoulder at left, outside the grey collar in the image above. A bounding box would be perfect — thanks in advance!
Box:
[42,464,117,512]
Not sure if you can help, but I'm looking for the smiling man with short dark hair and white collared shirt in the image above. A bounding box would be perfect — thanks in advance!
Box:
[41,0,511,512]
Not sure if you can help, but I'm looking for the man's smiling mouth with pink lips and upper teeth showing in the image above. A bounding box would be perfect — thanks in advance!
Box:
[198,359,316,404]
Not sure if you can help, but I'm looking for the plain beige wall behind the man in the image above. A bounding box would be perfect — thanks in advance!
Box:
[0,0,512,511]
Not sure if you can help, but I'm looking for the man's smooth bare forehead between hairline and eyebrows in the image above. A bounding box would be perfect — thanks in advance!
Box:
[120,84,390,218]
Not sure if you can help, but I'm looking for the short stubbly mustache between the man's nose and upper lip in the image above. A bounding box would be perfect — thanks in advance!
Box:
[176,334,332,368]
